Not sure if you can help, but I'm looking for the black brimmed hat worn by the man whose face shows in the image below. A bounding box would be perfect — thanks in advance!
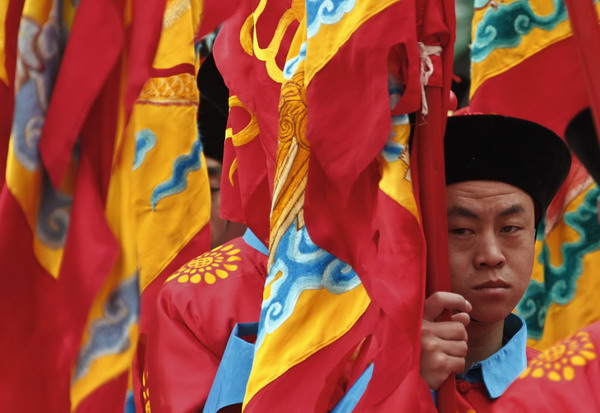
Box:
[444,115,571,217]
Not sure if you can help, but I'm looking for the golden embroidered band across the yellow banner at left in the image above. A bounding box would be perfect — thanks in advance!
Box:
[136,73,199,106]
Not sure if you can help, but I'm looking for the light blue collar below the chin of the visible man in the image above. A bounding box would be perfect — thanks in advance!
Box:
[457,313,527,399]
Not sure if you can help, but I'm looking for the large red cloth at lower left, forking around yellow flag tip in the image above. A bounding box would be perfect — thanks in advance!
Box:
[0,134,117,412]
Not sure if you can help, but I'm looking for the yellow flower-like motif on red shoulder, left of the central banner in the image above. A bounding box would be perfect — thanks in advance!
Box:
[165,244,242,284]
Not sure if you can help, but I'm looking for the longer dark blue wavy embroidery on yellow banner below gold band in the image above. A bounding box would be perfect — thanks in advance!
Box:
[150,135,202,211]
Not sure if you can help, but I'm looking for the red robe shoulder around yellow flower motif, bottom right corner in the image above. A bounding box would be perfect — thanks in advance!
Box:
[493,323,600,413]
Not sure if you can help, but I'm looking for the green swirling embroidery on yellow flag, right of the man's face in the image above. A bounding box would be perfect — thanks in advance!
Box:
[517,186,600,339]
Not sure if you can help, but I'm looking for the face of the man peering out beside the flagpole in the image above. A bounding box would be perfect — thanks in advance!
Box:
[446,181,535,323]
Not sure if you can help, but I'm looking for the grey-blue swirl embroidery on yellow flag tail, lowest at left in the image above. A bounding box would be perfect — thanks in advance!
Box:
[73,275,140,381]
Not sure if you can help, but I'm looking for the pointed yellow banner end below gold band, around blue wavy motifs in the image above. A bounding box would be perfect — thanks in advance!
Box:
[130,104,210,291]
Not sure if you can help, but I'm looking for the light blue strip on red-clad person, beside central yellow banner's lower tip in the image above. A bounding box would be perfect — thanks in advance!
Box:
[203,323,258,413]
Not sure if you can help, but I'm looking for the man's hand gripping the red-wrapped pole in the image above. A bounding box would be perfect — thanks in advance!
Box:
[421,291,472,390]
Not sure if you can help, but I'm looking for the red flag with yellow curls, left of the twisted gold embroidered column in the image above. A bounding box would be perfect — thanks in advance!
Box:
[213,0,298,241]
